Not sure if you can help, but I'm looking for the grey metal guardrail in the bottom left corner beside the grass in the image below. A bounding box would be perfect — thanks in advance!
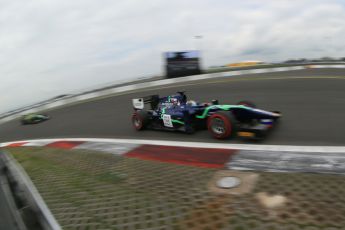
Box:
[0,152,61,230]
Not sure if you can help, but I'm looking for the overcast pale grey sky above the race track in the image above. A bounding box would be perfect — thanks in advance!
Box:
[0,0,345,113]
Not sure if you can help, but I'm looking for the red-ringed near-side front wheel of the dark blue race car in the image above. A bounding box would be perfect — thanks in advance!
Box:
[207,111,237,139]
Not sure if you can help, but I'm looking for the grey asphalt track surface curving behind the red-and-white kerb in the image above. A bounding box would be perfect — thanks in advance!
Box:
[0,69,345,146]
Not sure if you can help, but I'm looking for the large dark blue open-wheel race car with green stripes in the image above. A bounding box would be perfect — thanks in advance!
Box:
[132,92,281,139]
